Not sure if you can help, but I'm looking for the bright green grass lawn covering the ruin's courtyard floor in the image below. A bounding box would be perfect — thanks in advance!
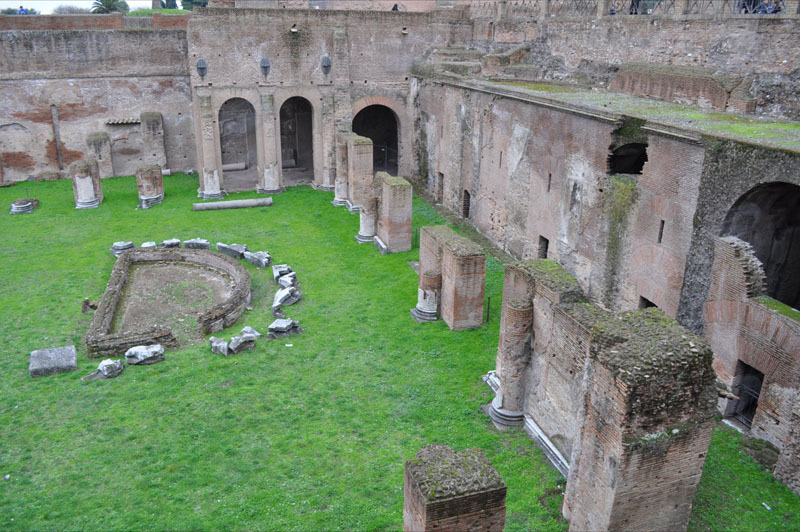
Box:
[0,174,800,531]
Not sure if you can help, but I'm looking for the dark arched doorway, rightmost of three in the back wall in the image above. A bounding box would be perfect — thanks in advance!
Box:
[353,105,400,175]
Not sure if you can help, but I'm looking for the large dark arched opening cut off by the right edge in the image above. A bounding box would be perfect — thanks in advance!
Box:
[722,183,800,308]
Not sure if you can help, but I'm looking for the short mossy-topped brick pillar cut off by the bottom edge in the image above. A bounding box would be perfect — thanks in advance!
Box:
[403,444,506,532]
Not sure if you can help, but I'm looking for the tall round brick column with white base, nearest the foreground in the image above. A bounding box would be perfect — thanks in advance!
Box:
[489,298,533,425]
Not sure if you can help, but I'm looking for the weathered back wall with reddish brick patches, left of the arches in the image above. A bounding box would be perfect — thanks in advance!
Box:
[0,28,195,182]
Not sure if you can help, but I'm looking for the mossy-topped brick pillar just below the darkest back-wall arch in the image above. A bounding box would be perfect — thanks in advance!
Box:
[376,172,412,253]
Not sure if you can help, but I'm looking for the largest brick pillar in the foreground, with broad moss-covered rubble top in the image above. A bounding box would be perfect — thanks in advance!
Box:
[563,310,716,531]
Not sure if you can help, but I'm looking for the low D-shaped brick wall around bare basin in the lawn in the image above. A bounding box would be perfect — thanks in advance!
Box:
[86,248,251,357]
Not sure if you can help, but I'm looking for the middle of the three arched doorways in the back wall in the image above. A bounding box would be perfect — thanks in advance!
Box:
[280,96,314,186]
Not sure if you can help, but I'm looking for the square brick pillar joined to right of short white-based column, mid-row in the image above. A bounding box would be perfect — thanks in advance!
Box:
[440,239,486,331]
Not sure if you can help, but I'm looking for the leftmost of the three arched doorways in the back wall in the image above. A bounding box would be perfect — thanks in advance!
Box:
[219,98,258,192]
